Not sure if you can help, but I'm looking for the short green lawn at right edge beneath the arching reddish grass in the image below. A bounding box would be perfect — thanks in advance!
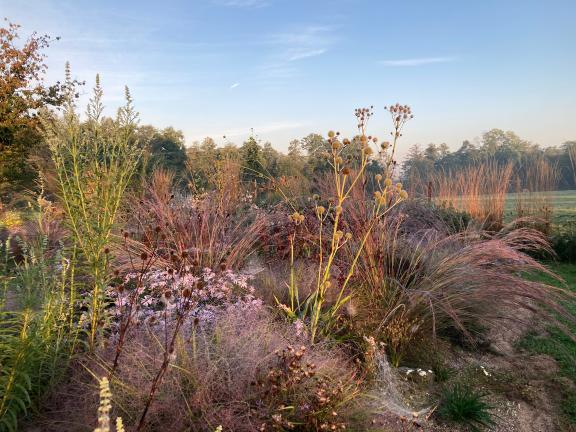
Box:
[520,264,576,424]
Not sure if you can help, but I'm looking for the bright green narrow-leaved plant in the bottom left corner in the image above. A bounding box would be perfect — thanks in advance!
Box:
[0,243,78,431]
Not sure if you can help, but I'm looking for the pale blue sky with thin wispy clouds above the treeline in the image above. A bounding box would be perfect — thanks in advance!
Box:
[0,0,576,155]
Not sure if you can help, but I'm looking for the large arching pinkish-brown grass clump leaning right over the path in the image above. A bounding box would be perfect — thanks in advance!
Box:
[354,202,570,366]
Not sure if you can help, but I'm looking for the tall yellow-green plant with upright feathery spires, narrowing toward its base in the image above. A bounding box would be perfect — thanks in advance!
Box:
[46,74,141,346]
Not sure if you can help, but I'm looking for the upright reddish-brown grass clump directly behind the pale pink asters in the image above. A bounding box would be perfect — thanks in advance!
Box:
[124,164,267,270]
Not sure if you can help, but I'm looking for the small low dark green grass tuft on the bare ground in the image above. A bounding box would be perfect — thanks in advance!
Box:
[437,384,495,431]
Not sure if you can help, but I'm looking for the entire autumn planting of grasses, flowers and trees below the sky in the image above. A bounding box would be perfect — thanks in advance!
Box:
[0,17,576,432]
